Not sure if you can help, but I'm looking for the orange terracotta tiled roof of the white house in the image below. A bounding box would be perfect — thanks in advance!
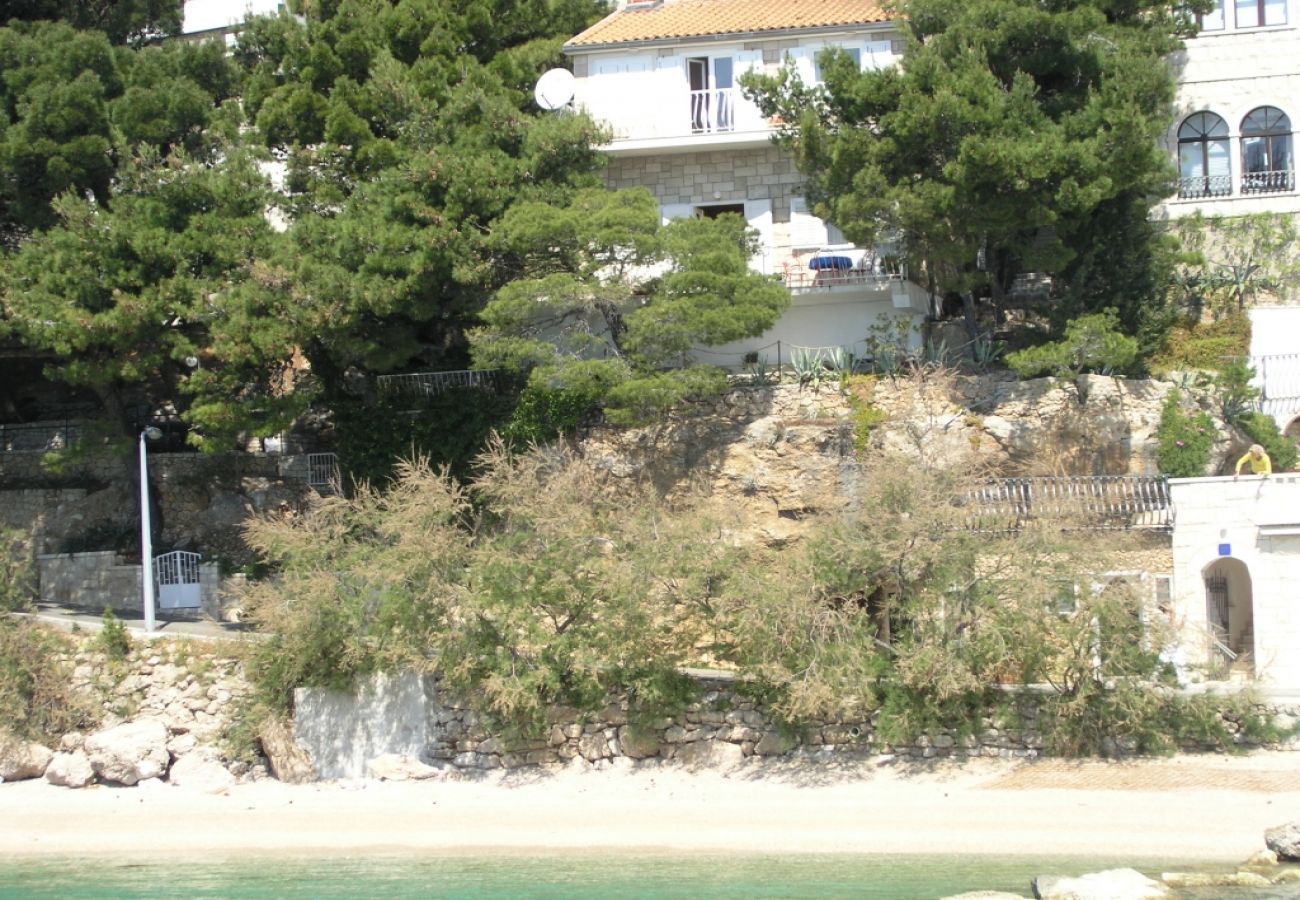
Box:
[564,0,889,47]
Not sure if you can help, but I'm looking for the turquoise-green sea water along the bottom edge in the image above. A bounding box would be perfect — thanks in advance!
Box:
[0,851,1300,900]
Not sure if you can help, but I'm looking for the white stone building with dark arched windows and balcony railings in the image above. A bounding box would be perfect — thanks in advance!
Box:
[1161,0,1300,218]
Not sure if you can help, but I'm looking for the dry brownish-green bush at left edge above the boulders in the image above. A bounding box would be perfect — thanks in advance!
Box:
[0,613,96,745]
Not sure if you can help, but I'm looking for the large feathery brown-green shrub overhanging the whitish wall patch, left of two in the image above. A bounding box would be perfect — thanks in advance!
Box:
[248,446,729,728]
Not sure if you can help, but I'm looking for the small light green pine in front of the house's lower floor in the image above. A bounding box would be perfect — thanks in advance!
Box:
[473,189,789,421]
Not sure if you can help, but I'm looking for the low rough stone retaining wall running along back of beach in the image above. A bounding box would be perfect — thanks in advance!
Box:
[294,674,1300,779]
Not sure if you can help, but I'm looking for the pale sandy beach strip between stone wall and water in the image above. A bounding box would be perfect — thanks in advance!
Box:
[0,753,1300,864]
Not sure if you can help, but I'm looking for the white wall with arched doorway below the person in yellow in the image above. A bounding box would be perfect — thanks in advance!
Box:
[1170,473,1300,691]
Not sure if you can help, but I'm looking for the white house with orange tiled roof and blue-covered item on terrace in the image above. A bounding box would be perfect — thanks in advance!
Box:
[564,0,930,368]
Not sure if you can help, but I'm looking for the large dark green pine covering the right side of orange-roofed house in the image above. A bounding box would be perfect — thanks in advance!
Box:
[744,0,1195,338]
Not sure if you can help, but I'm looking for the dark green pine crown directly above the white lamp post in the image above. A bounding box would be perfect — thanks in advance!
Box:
[4,150,293,440]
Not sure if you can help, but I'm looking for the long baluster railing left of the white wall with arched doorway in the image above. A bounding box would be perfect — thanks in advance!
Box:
[963,475,1174,531]
